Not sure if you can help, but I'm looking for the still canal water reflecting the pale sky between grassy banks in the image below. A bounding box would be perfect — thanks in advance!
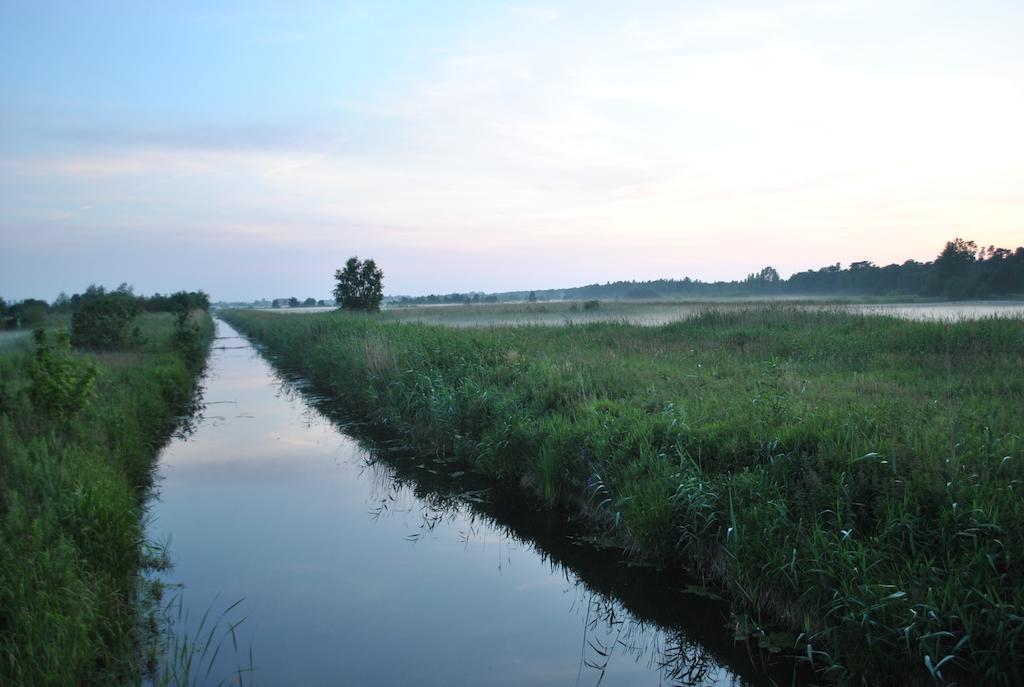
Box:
[150,321,790,686]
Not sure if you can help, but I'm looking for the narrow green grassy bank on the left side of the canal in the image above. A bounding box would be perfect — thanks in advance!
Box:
[0,312,213,686]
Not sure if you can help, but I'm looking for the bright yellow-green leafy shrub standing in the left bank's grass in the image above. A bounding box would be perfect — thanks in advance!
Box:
[29,330,96,426]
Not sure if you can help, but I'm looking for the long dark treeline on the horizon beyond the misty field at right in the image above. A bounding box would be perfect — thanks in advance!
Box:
[393,239,1024,304]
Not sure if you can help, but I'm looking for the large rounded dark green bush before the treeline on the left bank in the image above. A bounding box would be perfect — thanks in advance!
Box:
[71,292,141,350]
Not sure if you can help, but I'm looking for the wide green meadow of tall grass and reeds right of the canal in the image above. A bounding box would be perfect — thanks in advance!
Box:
[225,305,1024,685]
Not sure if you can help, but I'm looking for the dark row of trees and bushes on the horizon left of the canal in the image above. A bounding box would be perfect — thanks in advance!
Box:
[0,284,210,329]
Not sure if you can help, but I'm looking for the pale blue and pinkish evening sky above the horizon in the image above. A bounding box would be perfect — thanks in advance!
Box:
[0,0,1024,301]
